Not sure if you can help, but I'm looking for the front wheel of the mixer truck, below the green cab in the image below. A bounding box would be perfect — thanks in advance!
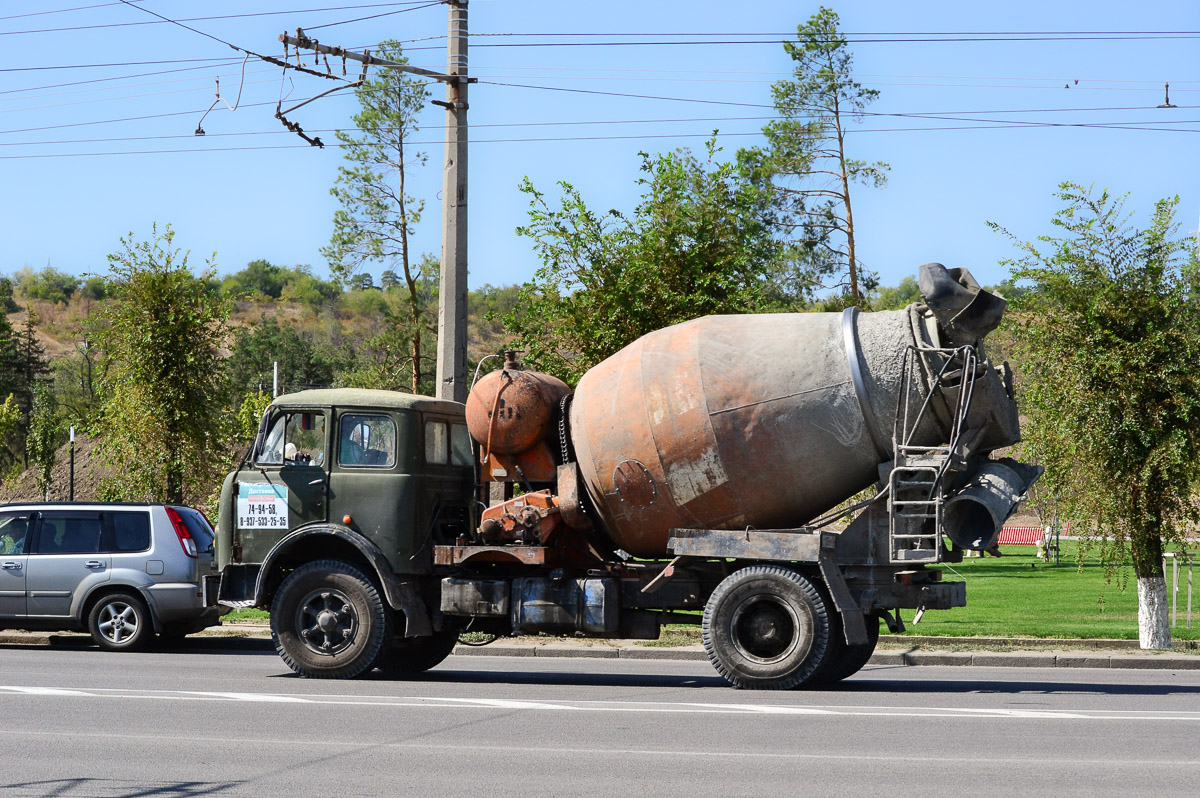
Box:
[271,560,388,679]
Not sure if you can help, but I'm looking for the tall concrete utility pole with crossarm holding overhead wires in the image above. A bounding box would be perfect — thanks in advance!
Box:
[280,0,472,402]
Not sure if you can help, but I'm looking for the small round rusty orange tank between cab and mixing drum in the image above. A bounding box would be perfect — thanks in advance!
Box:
[467,362,571,457]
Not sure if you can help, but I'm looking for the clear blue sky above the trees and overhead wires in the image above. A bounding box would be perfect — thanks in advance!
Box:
[0,0,1200,292]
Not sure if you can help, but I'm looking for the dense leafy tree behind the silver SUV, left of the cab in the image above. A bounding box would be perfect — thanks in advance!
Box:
[88,226,228,502]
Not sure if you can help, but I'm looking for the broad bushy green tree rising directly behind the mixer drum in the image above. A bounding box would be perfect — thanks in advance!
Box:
[505,137,780,380]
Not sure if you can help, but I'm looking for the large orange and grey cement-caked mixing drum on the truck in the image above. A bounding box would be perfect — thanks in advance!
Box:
[571,312,936,557]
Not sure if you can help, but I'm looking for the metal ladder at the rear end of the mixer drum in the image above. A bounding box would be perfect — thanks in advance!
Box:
[888,347,978,564]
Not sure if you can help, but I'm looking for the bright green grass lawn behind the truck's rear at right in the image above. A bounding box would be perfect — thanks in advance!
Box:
[904,541,1200,640]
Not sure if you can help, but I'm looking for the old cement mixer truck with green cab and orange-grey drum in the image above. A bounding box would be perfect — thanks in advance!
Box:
[217,264,1038,689]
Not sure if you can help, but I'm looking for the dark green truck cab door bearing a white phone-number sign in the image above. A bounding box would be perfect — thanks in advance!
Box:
[234,408,329,562]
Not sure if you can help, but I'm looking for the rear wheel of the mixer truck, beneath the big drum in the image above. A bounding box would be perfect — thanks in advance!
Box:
[701,565,833,690]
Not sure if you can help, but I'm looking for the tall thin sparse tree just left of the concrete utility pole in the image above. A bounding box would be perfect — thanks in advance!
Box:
[322,41,436,392]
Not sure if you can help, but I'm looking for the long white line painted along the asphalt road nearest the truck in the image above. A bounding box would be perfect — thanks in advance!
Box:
[0,685,1200,722]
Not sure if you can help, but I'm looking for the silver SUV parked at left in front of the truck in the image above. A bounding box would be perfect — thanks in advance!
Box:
[0,502,229,650]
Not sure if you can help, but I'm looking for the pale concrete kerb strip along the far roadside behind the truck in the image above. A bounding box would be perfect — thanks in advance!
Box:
[7,624,1200,671]
